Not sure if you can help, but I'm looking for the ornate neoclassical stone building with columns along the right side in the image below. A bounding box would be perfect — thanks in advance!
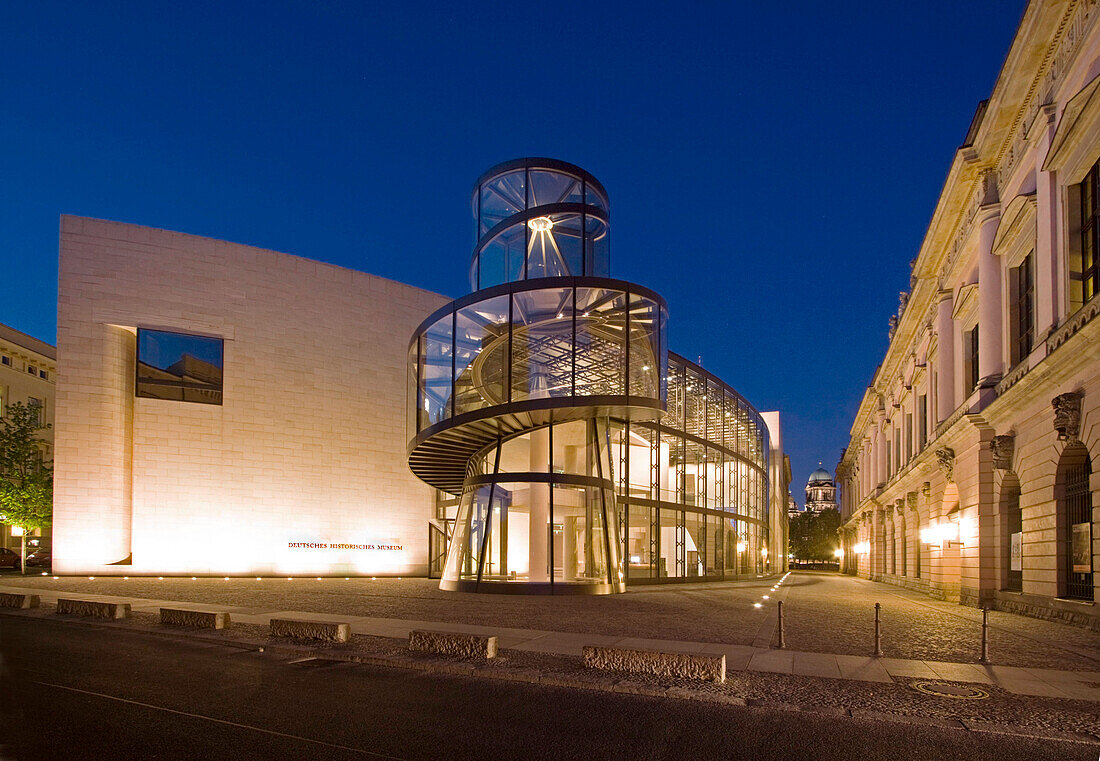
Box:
[837,0,1100,628]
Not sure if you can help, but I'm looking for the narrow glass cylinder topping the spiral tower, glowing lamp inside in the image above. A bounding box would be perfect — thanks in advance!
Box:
[470,158,611,290]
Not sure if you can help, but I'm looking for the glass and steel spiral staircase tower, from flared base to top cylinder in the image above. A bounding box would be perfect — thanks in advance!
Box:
[408,158,668,594]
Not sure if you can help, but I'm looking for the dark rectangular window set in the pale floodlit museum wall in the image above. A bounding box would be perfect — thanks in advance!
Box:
[136,329,222,405]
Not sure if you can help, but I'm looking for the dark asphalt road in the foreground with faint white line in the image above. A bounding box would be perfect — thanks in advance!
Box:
[0,614,1097,761]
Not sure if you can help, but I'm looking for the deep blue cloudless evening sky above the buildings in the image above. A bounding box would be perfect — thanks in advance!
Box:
[0,0,1025,504]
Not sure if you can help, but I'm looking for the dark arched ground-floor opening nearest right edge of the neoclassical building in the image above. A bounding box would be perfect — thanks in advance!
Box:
[1054,443,1092,599]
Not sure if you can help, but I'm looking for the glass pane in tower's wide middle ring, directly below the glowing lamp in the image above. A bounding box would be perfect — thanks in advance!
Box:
[512,288,573,401]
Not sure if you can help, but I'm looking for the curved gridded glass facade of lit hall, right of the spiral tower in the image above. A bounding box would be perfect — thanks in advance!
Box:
[612,355,769,584]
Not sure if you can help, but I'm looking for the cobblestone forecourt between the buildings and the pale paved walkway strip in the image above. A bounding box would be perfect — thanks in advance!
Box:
[8,573,1100,671]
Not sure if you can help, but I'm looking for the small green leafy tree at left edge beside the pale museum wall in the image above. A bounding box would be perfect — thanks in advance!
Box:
[0,401,54,574]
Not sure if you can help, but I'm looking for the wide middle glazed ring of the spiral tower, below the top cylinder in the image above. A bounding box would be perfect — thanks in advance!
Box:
[409,277,668,433]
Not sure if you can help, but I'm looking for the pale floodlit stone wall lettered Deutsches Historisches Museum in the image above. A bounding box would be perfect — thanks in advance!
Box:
[54,217,447,575]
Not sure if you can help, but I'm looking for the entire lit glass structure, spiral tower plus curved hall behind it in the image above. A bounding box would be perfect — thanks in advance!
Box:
[408,158,785,593]
